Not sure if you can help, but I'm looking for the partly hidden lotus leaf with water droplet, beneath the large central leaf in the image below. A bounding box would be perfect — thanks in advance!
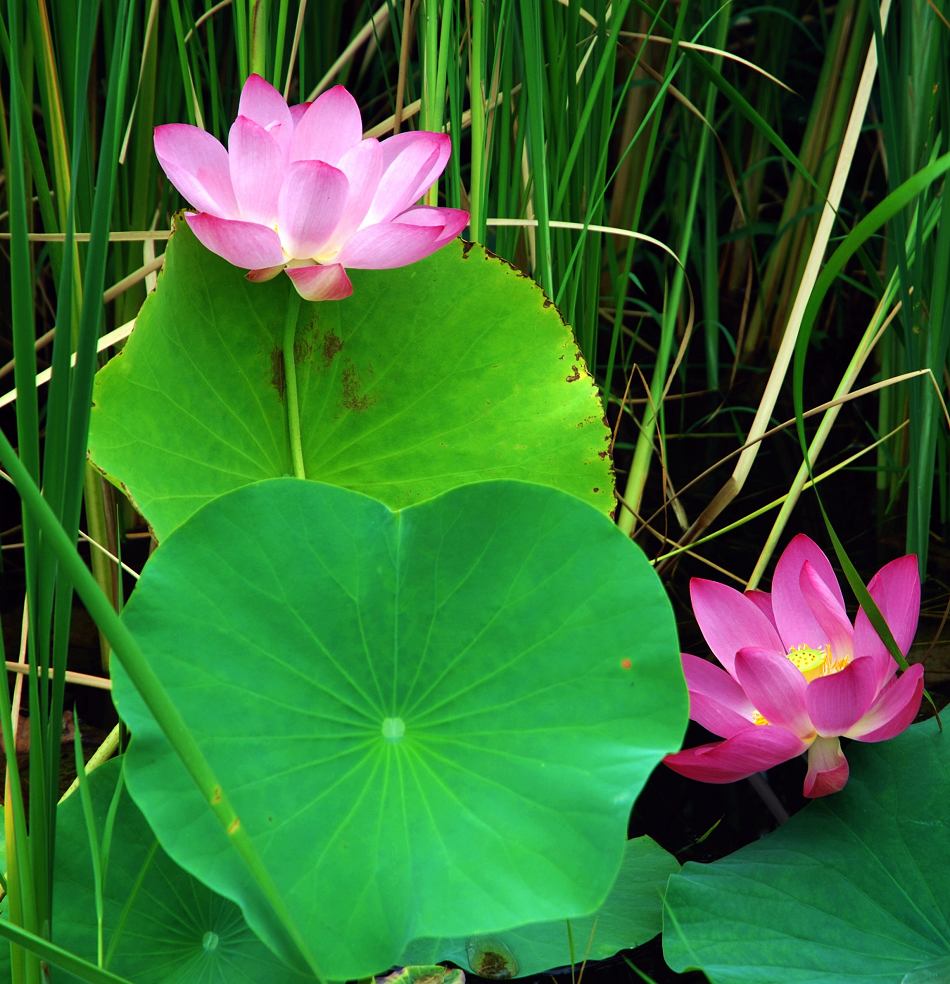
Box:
[403,837,680,978]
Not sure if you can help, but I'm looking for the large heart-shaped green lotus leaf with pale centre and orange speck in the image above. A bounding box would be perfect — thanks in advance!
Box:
[113,479,687,980]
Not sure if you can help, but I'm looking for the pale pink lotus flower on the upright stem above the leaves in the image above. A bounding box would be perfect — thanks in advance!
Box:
[155,75,468,301]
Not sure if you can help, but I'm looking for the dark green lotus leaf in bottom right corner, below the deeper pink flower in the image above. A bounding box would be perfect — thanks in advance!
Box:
[663,720,950,984]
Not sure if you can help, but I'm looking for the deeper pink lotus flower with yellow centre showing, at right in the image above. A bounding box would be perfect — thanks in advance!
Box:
[664,534,924,797]
